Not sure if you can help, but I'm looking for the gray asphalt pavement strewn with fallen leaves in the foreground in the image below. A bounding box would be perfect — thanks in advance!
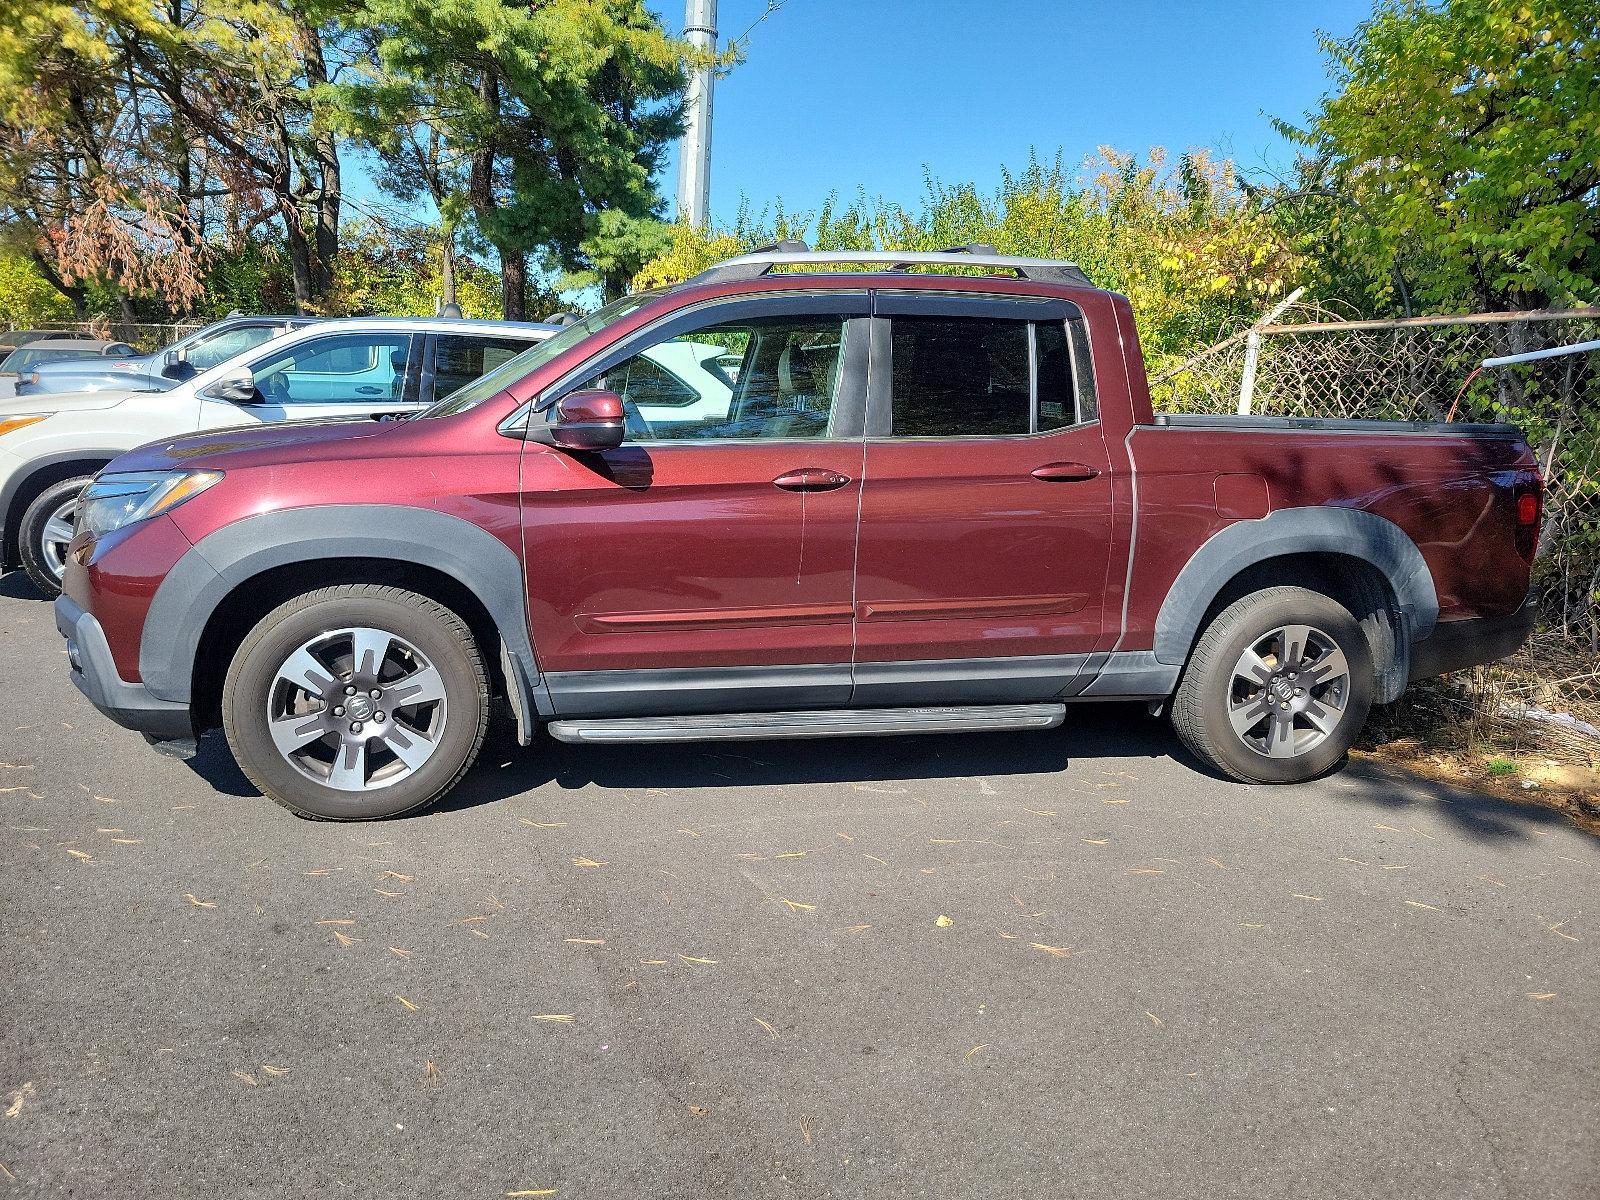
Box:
[0,576,1600,1200]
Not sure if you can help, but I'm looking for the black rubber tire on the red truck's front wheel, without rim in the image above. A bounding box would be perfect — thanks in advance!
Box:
[222,584,490,821]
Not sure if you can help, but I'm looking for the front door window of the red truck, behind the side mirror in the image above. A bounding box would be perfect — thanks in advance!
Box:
[586,317,846,442]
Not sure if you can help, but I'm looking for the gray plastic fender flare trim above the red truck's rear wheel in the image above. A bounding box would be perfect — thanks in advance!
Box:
[1155,507,1438,666]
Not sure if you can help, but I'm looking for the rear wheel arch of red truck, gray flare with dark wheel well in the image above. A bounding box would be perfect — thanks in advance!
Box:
[1154,507,1438,702]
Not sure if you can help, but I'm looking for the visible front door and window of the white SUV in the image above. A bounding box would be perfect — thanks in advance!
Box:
[202,330,421,427]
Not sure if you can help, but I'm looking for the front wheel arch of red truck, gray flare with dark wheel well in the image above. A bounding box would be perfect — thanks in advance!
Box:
[139,504,546,739]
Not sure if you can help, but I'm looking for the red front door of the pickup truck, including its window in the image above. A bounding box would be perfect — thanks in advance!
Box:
[522,293,870,715]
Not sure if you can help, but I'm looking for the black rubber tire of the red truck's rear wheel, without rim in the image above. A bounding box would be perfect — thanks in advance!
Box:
[1173,587,1374,784]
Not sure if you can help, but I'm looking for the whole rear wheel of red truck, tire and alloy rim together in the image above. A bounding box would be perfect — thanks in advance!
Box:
[1173,587,1374,784]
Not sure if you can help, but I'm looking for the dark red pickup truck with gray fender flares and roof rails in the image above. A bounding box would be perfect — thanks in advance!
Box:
[56,246,1541,819]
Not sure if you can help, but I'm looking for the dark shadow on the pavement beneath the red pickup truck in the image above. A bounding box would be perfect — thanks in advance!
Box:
[189,704,1587,842]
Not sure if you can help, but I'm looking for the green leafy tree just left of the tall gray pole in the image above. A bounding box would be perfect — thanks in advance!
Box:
[334,0,691,318]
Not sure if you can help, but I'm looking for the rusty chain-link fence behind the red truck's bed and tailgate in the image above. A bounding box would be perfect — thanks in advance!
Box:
[1150,309,1600,755]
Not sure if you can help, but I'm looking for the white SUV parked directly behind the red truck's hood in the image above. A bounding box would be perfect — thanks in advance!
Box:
[0,317,552,595]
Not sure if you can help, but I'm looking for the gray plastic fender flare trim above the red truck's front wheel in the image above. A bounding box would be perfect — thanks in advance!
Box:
[139,504,542,718]
